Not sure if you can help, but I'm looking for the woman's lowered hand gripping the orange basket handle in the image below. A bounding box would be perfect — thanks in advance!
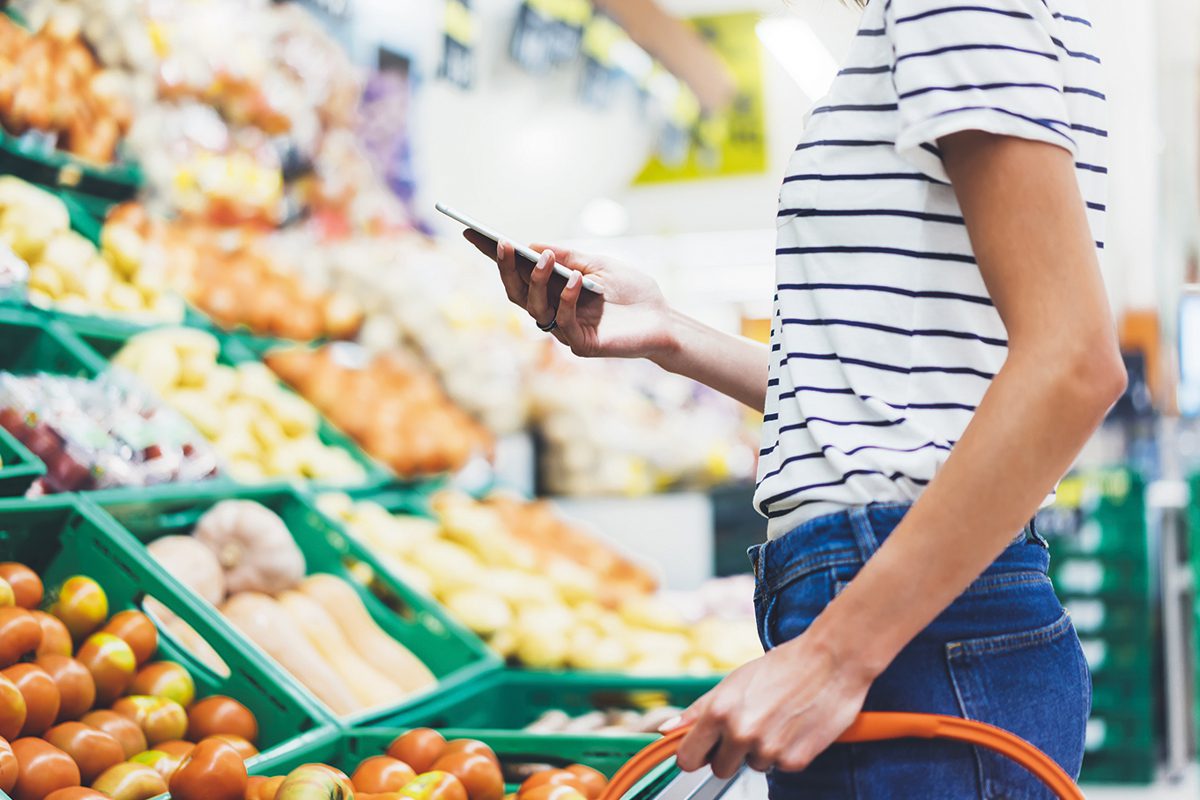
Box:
[677,634,872,778]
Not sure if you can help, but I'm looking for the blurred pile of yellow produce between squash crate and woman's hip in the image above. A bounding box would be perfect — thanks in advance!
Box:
[318,493,762,675]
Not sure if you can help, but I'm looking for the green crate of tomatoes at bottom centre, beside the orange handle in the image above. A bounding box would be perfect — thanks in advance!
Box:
[250,728,678,800]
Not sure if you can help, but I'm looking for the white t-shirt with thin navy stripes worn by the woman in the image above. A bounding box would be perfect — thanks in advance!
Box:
[755,0,1108,537]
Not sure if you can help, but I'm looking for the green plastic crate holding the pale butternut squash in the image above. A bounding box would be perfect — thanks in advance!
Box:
[84,486,499,724]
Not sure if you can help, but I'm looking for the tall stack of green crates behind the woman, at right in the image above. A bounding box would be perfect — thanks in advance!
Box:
[1038,469,1158,783]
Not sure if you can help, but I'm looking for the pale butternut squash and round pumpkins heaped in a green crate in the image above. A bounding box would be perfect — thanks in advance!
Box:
[146,500,437,715]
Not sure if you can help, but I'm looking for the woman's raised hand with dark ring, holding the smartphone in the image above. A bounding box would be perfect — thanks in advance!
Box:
[463,229,672,357]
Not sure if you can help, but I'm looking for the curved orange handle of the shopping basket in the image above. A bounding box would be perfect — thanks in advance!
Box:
[599,711,1084,800]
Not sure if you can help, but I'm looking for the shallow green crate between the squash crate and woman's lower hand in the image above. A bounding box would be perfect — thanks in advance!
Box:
[373,669,720,730]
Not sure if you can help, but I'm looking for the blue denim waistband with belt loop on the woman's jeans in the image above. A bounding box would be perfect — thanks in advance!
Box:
[748,503,1050,593]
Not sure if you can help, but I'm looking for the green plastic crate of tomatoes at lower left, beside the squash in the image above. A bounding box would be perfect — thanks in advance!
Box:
[0,495,334,762]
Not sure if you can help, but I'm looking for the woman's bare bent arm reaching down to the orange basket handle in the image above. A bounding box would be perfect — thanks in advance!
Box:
[679,131,1126,776]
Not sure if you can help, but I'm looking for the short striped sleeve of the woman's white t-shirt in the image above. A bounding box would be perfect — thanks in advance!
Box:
[884,0,1076,182]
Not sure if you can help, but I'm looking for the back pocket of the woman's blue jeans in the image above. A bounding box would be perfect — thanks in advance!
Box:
[946,612,1091,800]
